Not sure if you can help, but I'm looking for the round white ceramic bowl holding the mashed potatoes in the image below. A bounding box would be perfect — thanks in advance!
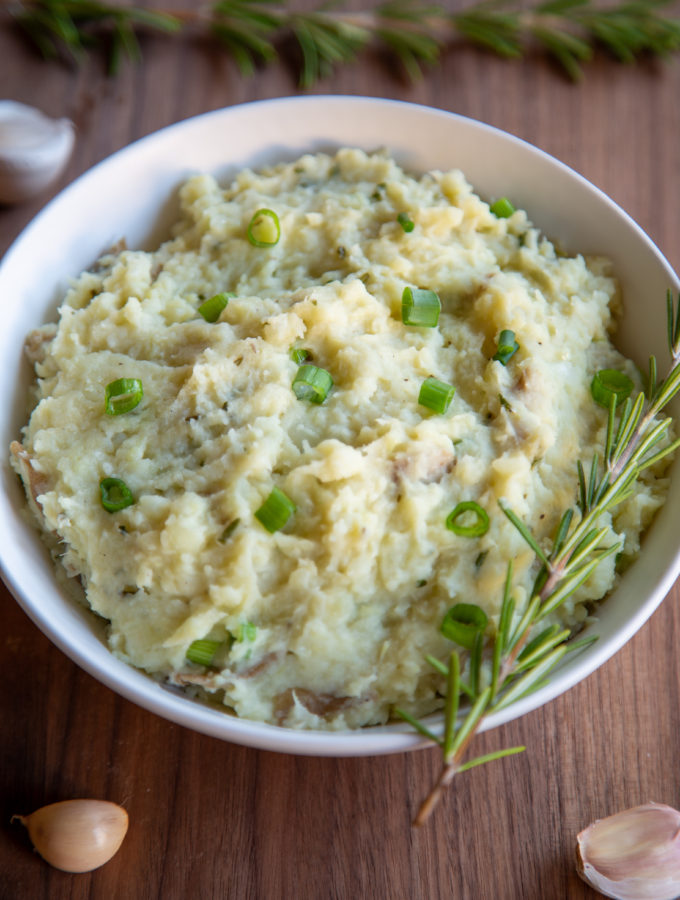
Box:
[0,97,680,756]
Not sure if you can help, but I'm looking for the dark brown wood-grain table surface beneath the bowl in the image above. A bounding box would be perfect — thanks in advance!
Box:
[0,4,680,900]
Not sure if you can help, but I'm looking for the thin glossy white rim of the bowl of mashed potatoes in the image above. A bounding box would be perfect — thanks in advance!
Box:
[0,95,680,757]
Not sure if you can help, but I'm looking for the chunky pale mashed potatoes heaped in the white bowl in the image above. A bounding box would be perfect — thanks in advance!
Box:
[13,150,665,728]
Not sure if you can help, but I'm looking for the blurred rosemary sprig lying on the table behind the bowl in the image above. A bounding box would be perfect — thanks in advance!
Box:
[0,0,680,87]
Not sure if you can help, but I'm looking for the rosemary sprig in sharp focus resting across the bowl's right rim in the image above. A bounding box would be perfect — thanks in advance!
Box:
[397,291,680,825]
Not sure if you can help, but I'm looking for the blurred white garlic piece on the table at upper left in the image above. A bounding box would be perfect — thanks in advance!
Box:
[0,100,75,204]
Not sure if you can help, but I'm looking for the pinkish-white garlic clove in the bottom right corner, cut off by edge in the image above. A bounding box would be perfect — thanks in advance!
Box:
[576,803,680,900]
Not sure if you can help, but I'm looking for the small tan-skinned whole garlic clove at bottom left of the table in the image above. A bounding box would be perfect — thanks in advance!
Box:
[12,800,128,872]
